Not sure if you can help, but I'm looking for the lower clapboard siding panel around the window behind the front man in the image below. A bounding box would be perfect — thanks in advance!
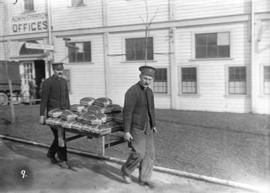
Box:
[109,30,170,108]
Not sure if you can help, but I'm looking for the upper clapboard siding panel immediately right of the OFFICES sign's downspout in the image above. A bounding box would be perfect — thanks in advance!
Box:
[52,0,102,30]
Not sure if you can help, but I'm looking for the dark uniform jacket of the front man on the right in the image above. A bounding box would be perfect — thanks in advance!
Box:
[123,82,156,132]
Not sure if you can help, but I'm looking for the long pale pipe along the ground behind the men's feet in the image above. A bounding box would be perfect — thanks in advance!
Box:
[0,135,264,193]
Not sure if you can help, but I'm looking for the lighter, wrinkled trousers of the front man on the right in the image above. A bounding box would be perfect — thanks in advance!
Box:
[121,124,155,182]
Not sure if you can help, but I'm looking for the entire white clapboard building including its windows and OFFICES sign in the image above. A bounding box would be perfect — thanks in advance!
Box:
[0,0,270,114]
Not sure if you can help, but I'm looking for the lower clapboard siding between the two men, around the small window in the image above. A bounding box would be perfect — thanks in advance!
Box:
[55,35,105,104]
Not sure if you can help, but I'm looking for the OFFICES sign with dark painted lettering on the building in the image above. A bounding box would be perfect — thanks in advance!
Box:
[11,13,48,33]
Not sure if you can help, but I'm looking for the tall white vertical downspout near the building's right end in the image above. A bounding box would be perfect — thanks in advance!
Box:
[250,0,254,113]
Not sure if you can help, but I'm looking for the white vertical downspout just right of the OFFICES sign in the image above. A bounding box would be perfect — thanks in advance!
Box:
[46,0,54,76]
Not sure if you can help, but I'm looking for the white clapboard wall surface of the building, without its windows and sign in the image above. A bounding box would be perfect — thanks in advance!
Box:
[0,0,270,113]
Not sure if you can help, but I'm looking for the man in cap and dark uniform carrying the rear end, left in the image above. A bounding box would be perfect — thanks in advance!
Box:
[40,63,70,169]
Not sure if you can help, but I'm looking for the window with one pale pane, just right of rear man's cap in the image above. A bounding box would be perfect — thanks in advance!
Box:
[68,42,91,62]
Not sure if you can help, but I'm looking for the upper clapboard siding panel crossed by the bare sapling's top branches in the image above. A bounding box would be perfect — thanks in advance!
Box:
[108,0,168,25]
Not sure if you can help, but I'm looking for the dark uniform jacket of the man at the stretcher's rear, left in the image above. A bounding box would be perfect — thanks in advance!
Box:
[40,75,70,116]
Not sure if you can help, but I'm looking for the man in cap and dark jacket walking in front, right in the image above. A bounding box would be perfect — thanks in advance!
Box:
[121,66,157,188]
